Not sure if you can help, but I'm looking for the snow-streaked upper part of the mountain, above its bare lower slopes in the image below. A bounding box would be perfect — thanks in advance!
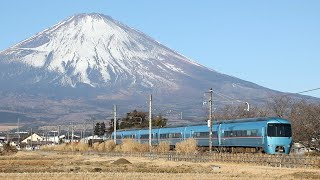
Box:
[0,14,206,90]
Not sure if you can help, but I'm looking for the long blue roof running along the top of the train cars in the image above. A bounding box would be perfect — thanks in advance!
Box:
[117,117,288,132]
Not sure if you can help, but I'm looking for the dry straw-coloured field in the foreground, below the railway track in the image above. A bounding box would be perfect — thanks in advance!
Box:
[0,152,320,180]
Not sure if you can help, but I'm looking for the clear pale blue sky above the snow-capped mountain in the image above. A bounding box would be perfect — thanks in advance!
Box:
[0,0,320,97]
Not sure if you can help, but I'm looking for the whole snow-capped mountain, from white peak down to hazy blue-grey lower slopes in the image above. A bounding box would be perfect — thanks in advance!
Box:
[0,13,300,120]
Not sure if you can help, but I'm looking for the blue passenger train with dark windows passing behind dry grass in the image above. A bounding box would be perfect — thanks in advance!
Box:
[112,117,292,154]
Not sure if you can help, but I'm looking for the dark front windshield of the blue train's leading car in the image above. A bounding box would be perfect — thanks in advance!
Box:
[267,123,292,137]
